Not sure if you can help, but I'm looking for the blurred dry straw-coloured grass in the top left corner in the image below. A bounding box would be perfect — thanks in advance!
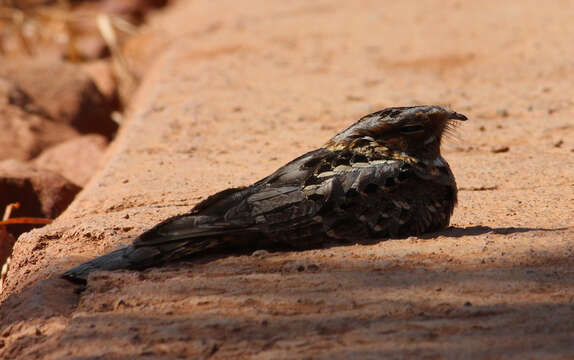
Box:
[0,0,139,105]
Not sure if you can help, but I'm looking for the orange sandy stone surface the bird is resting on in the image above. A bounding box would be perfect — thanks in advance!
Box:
[0,0,574,359]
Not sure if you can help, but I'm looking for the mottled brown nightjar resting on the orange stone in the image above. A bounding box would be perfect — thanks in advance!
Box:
[62,105,467,283]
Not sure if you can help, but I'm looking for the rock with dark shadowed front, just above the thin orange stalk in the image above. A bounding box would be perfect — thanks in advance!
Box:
[0,160,81,236]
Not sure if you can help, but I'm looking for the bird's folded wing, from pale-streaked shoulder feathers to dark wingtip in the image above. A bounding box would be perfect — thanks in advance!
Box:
[133,143,432,247]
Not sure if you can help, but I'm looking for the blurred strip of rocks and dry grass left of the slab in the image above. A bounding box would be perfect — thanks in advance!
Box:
[0,0,169,286]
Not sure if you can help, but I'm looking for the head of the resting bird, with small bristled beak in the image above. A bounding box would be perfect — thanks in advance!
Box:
[326,105,467,159]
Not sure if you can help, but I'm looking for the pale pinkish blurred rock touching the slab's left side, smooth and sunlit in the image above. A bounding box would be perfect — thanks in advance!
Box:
[34,134,107,187]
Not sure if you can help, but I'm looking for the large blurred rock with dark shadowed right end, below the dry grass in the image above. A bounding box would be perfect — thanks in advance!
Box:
[0,58,117,138]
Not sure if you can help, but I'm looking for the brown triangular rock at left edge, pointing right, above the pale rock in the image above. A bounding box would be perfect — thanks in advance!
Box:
[0,78,77,160]
